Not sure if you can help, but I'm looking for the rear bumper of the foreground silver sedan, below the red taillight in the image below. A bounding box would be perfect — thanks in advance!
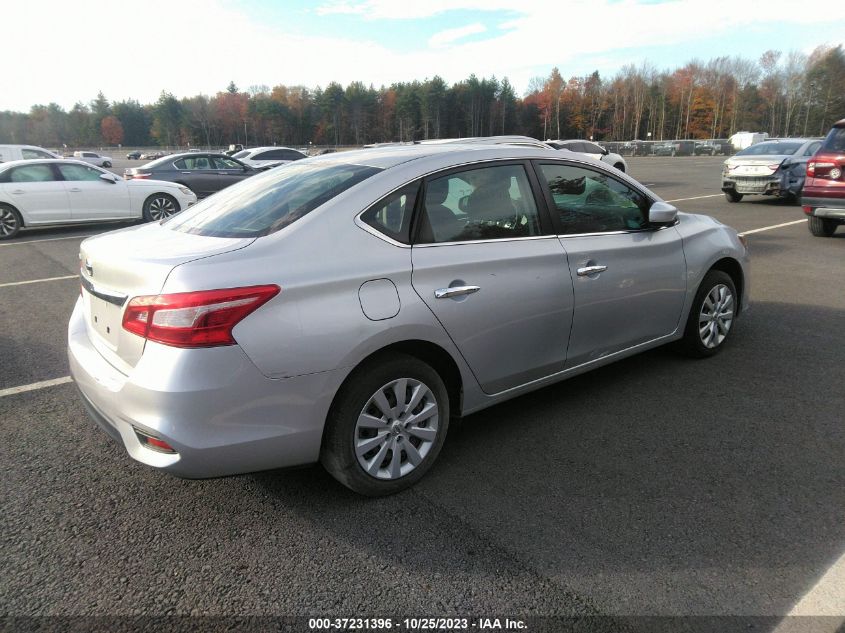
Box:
[68,304,339,478]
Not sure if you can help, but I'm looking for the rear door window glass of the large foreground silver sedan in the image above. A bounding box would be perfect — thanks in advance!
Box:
[419,165,540,243]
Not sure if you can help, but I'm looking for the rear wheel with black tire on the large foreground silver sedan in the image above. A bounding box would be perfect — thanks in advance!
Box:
[320,354,449,497]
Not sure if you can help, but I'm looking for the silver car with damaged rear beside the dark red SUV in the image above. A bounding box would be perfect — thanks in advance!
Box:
[722,138,822,202]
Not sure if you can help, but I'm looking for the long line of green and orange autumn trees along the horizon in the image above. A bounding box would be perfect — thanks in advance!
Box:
[0,46,845,147]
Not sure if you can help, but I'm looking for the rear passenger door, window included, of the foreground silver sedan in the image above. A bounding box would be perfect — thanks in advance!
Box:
[411,162,572,394]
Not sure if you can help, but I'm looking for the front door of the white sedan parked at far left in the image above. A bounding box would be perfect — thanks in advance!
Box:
[56,163,131,220]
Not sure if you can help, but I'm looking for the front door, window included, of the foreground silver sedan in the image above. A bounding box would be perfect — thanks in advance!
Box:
[537,161,686,367]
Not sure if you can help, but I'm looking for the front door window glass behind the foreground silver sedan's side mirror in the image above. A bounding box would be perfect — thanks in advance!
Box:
[540,164,648,235]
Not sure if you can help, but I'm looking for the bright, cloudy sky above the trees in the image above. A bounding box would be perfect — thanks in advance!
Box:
[6,0,845,111]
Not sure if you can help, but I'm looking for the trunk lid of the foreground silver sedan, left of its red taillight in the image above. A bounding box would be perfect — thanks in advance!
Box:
[79,223,254,374]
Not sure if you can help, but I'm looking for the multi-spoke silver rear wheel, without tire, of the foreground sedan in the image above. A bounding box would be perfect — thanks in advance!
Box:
[355,378,439,480]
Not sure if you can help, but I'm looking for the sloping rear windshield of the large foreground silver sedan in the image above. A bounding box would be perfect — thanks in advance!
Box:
[165,163,381,237]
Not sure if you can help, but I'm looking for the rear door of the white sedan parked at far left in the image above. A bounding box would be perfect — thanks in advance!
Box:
[0,162,71,224]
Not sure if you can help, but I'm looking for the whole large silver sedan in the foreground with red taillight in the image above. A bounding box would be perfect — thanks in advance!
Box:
[68,144,749,495]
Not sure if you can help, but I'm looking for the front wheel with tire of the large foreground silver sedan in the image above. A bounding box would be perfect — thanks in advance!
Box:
[677,270,739,358]
